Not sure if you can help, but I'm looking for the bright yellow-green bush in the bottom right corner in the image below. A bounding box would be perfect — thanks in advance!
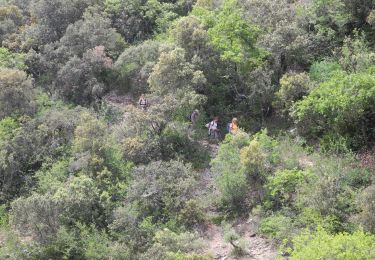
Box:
[287,228,375,260]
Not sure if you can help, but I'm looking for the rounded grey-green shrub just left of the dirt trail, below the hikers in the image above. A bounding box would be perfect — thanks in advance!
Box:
[127,161,197,223]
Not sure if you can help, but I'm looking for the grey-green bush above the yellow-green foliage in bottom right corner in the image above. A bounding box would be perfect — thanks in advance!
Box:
[295,156,369,232]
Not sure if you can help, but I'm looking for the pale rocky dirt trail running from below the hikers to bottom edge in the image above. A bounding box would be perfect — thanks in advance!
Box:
[202,141,277,260]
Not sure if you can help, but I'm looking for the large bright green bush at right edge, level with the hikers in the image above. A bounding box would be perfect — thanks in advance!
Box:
[292,70,375,148]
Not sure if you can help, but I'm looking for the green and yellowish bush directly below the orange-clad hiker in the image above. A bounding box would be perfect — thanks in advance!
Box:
[212,131,277,213]
